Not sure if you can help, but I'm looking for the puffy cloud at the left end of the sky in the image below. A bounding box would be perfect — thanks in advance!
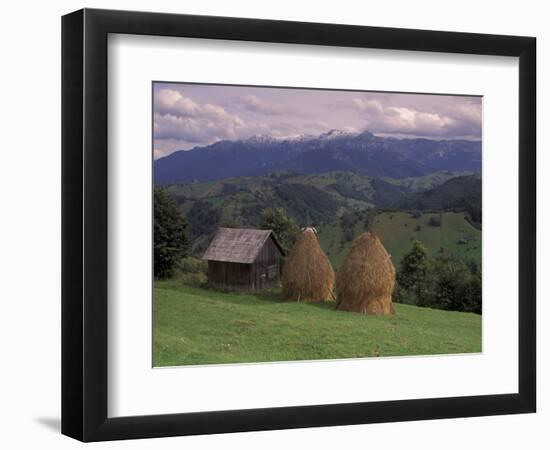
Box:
[153,89,246,148]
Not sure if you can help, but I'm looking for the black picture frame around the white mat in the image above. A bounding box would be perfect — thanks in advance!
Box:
[62,9,536,441]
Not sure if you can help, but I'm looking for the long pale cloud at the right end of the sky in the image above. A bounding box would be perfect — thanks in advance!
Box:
[350,96,481,138]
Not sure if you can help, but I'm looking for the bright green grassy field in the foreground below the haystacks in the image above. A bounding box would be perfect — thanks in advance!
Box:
[153,280,481,366]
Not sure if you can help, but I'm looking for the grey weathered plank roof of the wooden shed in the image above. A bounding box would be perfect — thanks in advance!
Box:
[202,228,284,264]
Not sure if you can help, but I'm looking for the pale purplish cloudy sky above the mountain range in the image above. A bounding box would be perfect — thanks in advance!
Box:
[153,83,482,159]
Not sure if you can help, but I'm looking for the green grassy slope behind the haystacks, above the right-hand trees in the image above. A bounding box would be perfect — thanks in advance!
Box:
[319,212,481,270]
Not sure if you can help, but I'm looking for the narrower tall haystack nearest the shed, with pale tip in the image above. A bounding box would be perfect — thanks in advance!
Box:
[281,227,335,302]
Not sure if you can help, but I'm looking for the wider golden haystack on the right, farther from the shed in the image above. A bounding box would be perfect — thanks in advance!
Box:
[336,233,395,314]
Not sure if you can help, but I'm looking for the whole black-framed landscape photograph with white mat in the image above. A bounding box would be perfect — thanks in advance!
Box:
[62,9,536,441]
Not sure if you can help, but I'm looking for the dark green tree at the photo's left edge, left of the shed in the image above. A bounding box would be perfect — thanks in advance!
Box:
[153,188,188,278]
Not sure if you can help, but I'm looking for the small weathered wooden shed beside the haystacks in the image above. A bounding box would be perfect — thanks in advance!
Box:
[202,228,284,291]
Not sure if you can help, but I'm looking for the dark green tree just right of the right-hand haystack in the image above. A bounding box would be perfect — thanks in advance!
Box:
[397,240,430,306]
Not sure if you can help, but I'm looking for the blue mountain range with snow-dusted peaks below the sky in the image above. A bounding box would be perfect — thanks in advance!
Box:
[154,130,481,185]
